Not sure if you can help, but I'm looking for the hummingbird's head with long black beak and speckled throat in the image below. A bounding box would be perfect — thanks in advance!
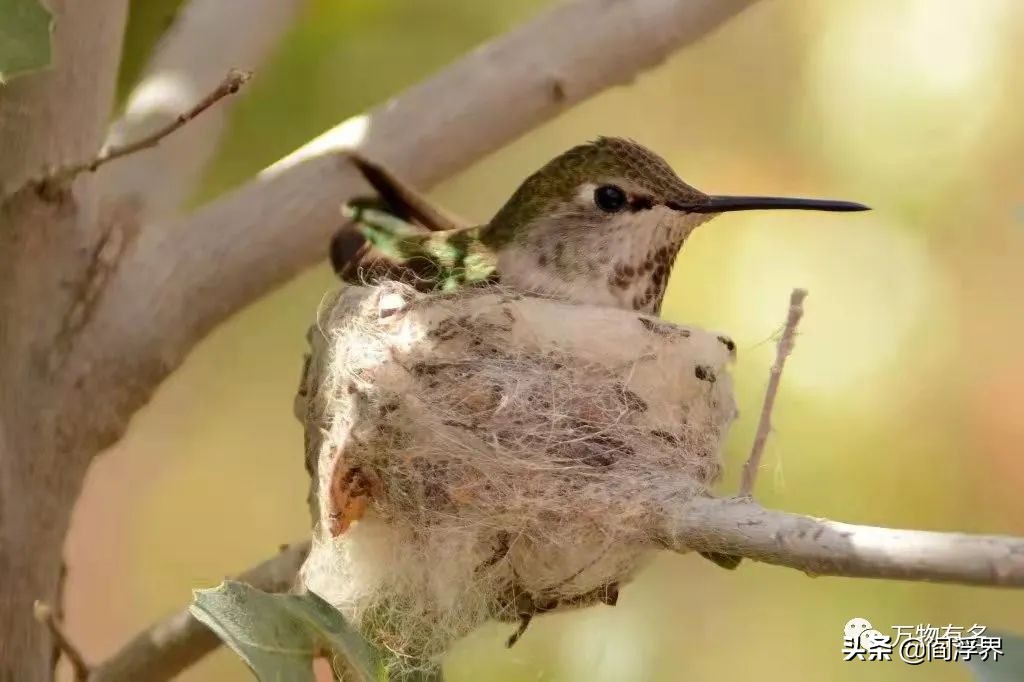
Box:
[481,137,866,312]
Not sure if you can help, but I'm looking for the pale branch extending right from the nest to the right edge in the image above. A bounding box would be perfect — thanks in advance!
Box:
[666,498,1024,588]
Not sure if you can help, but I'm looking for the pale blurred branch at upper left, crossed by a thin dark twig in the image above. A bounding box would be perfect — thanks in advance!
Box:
[100,0,306,220]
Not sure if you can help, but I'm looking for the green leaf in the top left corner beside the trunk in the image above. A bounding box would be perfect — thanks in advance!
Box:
[0,0,52,84]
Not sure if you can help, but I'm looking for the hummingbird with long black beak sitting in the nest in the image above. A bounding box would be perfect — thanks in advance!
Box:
[331,137,868,315]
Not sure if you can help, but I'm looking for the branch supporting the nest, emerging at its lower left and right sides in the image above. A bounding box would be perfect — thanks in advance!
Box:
[89,497,1024,682]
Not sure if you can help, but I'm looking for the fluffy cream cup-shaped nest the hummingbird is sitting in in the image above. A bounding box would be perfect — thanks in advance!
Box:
[296,284,736,659]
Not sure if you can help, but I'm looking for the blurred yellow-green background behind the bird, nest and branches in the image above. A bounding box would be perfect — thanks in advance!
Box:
[68,0,1024,682]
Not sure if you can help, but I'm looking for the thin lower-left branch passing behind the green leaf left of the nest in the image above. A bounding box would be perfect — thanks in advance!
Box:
[89,542,309,682]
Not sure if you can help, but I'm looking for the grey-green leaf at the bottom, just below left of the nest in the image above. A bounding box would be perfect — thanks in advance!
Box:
[189,581,378,682]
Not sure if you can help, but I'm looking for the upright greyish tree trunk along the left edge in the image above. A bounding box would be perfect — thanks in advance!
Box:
[0,0,128,681]
